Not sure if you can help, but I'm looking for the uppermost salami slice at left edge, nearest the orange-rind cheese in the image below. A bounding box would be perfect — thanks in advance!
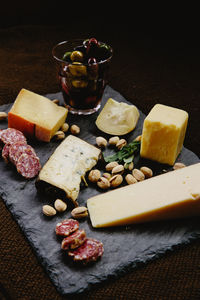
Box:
[1,128,26,144]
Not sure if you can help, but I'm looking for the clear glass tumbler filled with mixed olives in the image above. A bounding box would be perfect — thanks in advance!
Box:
[52,38,113,115]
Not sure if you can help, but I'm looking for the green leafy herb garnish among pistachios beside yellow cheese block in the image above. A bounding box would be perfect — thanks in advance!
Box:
[103,141,140,166]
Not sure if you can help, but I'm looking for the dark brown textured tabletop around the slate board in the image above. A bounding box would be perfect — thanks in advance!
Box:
[0,17,200,300]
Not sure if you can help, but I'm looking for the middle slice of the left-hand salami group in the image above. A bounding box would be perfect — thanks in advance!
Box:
[9,141,36,165]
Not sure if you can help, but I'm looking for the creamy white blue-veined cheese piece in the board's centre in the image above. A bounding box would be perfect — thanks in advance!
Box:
[38,135,101,205]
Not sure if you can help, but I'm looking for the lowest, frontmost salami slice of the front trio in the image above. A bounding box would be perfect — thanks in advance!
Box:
[68,238,104,264]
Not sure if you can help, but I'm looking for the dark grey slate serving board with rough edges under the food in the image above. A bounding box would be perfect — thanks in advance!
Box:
[0,86,200,294]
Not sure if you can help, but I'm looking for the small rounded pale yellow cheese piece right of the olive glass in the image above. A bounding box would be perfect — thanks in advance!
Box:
[96,98,140,135]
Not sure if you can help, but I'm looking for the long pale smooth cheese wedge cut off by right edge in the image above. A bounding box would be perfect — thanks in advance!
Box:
[87,163,200,227]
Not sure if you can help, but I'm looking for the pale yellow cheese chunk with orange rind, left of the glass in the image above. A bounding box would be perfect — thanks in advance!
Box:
[8,89,68,142]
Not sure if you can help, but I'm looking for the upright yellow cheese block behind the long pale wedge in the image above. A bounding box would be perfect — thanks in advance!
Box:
[140,104,188,165]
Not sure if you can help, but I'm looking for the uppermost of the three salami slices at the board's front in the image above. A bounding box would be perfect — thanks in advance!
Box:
[56,219,79,236]
